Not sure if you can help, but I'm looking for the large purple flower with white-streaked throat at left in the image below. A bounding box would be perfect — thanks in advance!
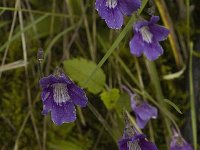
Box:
[39,68,88,125]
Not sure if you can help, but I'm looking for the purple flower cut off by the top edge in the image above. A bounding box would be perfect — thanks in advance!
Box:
[95,0,141,29]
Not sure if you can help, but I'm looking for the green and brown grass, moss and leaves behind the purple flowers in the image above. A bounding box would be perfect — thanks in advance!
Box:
[0,0,200,150]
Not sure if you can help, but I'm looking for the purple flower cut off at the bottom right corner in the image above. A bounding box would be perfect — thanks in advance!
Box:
[170,130,193,150]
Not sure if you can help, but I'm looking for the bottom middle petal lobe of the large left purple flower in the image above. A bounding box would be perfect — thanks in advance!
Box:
[51,102,76,125]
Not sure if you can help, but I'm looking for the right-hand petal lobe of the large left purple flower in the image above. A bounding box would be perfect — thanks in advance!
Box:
[68,83,88,107]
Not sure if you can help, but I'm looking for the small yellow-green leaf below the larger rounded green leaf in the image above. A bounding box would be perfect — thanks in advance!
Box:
[100,88,120,109]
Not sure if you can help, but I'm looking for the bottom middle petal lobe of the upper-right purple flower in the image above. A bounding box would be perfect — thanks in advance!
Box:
[144,42,163,61]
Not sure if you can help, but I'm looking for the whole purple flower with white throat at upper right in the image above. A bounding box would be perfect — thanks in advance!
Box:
[129,16,169,61]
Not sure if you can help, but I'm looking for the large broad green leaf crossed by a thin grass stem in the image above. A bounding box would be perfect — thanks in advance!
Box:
[63,58,106,94]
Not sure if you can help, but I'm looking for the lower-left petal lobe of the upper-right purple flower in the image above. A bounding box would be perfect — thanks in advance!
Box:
[129,32,144,57]
